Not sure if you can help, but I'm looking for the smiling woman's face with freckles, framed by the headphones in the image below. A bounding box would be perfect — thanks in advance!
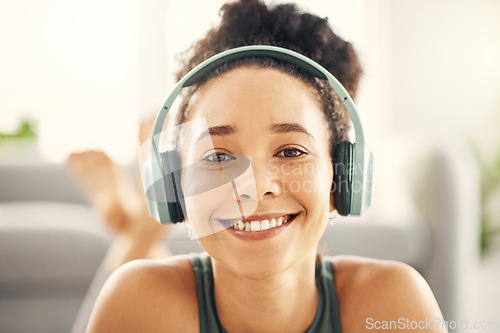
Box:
[181,66,333,279]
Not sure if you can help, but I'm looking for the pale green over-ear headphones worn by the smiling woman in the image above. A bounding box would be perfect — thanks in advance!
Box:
[142,45,373,224]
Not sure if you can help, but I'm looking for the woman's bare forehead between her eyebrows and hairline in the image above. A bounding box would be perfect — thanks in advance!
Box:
[186,66,324,128]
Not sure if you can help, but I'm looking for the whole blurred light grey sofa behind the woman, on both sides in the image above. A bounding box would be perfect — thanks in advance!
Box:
[0,134,479,332]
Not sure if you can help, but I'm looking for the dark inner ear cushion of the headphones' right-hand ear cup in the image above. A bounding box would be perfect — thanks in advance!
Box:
[332,141,354,216]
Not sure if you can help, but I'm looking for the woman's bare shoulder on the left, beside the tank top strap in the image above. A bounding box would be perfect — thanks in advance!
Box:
[88,256,198,332]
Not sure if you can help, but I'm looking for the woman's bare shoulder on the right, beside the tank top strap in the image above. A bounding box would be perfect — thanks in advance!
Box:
[333,256,446,332]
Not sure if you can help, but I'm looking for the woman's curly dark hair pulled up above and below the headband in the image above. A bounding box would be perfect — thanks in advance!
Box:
[176,0,363,150]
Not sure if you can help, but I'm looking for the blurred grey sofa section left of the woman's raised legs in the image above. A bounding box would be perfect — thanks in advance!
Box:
[0,202,110,332]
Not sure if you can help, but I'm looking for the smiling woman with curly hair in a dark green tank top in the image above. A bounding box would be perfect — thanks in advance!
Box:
[89,0,445,332]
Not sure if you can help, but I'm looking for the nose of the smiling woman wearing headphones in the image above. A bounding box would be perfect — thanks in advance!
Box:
[235,160,282,201]
